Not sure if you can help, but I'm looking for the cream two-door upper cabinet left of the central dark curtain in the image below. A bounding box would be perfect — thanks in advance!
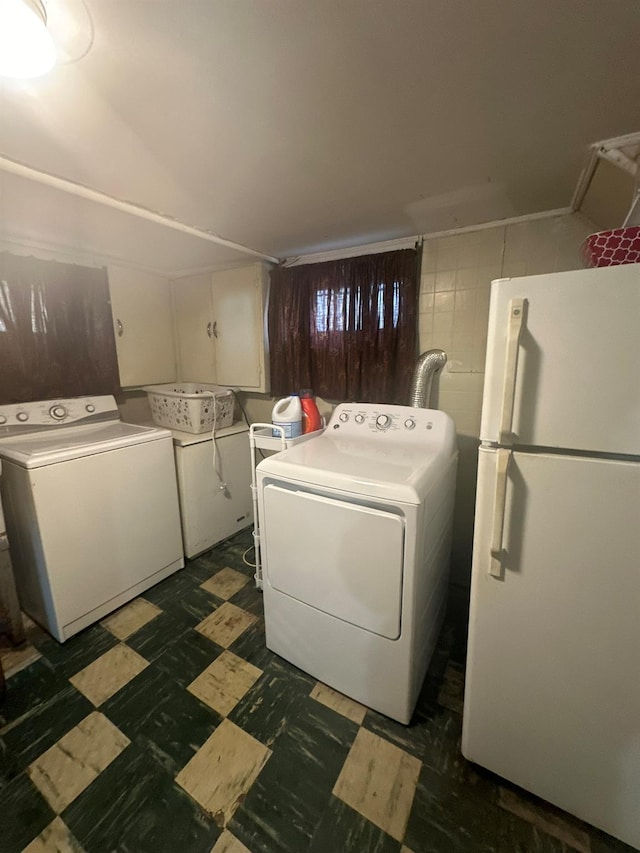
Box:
[173,263,269,392]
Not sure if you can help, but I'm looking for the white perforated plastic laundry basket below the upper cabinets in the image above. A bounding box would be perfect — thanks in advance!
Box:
[143,382,234,433]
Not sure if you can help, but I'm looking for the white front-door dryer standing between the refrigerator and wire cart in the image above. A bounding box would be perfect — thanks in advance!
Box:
[257,403,457,723]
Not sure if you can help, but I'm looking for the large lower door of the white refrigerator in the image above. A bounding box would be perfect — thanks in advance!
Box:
[462,448,640,847]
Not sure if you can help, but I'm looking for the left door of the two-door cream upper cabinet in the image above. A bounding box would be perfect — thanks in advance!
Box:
[173,273,216,382]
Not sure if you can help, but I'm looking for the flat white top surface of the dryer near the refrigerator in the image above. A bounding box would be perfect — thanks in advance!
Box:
[257,432,455,504]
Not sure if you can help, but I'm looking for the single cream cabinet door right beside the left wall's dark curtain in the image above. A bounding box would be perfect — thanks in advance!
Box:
[108,266,176,388]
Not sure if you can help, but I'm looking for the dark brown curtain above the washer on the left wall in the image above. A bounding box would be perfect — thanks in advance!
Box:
[0,252,120,404]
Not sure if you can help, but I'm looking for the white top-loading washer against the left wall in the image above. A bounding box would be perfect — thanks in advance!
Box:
[0,396,184,642]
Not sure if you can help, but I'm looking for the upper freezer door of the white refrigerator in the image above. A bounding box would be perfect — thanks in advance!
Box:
[480,264,640,455]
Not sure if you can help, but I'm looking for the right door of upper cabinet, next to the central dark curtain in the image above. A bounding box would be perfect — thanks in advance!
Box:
[212,264,268,391]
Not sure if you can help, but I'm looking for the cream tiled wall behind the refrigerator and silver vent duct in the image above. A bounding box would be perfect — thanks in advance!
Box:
[419,214,597,585]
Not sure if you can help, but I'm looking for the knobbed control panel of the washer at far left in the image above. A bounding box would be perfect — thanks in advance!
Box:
[0,396,120,437]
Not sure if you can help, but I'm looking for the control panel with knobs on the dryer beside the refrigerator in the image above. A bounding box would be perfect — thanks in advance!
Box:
[327,403,442,440]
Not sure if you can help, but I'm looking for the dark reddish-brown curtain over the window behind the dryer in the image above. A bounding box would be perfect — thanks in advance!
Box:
[269,249,420,405]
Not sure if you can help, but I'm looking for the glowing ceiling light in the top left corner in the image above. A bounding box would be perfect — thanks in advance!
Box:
[0,0,56,79]
